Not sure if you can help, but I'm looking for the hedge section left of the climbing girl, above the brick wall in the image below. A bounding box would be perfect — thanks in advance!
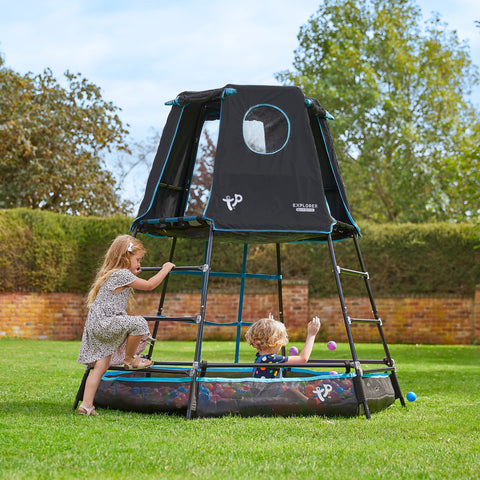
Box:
[0,208,130,293]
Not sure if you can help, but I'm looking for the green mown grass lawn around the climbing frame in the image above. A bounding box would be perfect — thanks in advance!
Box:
[0,339,480,480]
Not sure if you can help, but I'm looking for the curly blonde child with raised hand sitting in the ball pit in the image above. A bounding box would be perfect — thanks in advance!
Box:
[245,315,320,378]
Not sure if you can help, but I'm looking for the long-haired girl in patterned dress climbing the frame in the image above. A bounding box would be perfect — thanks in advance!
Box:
[78,235,175,416]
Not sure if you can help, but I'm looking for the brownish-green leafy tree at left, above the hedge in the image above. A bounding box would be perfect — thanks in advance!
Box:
[0,61,129,216]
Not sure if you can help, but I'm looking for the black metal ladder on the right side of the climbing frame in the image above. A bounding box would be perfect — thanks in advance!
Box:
[328,233,405,418]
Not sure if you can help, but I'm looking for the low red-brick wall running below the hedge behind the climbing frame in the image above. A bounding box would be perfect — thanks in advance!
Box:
[0,281,480,344]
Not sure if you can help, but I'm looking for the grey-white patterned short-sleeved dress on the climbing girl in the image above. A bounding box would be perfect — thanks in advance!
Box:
[77,269,150,364]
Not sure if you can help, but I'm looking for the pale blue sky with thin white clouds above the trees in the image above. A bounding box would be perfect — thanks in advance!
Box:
[0,0,480,204]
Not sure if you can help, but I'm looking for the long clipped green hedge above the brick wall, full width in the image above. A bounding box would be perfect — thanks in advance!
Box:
[0,209,480,297]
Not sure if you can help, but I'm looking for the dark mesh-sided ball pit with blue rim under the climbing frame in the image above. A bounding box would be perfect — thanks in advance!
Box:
[95,368,394,417]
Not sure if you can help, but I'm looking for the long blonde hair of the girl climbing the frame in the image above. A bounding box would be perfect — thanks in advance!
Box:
[87,235,145,307]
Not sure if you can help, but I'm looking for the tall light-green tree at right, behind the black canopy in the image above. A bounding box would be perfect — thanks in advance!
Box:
[277,0,480,222]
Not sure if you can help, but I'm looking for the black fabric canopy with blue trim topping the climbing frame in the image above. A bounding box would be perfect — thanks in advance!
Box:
[132,85,358,243]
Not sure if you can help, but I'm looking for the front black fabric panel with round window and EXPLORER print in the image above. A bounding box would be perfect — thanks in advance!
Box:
[206,85,334,236]
